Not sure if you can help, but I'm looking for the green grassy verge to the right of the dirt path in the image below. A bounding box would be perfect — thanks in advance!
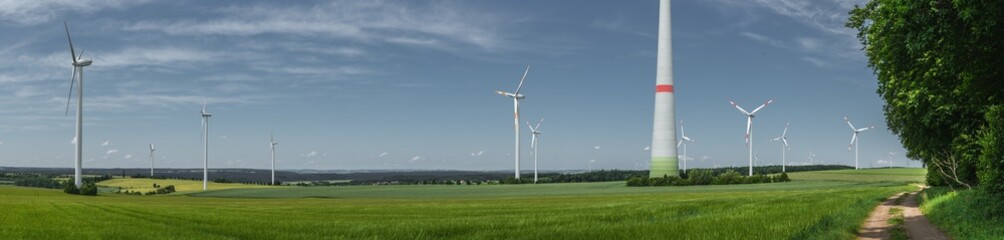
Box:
[920,187,1004,239]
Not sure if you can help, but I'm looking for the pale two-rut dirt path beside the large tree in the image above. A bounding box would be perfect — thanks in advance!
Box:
[857,192,951,240]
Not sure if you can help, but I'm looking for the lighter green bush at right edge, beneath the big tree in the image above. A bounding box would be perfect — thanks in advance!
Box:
[977,105,1004,194]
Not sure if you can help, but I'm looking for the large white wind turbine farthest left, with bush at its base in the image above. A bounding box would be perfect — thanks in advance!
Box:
[63,22,92,188]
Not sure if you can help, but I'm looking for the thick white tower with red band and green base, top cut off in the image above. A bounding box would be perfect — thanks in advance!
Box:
[649,0,680,178]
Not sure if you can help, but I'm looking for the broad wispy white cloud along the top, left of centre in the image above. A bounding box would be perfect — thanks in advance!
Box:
[126,1,508,51]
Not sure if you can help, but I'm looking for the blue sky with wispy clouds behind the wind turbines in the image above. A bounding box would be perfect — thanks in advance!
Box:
[0,0,918,170]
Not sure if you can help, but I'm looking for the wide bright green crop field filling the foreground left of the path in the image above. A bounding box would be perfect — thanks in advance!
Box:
[0,171,923,239]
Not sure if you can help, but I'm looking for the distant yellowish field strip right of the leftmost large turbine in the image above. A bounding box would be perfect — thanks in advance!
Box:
[97,179,276,194]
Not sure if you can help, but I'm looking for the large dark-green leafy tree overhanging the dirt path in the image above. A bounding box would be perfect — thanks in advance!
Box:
[846,0,1004,187]
